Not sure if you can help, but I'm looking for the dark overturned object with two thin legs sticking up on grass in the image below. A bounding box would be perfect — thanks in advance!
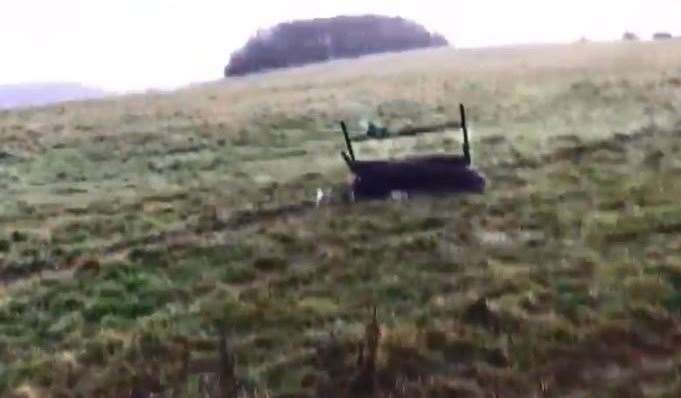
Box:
[341,104,485,199]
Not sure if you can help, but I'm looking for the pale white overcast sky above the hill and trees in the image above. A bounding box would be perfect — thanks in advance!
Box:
[0,0,681,91]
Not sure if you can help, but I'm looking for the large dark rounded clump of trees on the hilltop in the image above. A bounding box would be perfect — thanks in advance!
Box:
[225,15,448,76]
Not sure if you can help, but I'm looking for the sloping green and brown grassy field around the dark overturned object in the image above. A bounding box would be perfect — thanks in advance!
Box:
[0,41,681,397]
